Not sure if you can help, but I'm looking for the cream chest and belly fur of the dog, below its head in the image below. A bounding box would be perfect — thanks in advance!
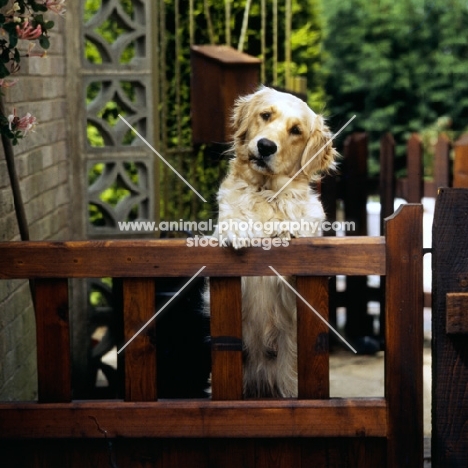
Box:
[218,175,324,398]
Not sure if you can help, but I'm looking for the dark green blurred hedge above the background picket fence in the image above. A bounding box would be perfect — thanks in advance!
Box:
[323,0,468,176]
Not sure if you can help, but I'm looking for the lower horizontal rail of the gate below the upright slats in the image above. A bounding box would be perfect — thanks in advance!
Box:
[0,398,388,438]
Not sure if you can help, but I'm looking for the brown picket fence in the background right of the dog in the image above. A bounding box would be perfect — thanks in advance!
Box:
[322,133,468,342]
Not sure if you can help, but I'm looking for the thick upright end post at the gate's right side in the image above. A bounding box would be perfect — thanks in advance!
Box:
[385,205,423,468]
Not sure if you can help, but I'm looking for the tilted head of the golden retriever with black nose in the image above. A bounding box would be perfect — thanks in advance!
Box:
[232,87,337,180]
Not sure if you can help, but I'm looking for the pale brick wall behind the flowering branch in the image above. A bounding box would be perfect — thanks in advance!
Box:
[0,17,71,401]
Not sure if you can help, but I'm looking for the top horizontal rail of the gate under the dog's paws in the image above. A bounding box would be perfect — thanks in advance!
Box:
[0,236,385,279]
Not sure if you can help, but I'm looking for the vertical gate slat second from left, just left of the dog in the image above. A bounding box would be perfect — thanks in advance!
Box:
[122,278,157,401]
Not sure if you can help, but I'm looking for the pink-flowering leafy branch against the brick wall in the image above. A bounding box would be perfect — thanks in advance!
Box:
[0,0,65,145]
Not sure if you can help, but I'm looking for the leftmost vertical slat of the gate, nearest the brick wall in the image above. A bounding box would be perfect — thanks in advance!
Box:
[35,279,72,403]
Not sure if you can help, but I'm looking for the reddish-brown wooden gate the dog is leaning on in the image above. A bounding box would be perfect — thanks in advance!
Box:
[0,205,423,468]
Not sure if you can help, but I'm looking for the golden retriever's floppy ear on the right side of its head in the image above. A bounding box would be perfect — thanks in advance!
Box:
[301,115,338,177]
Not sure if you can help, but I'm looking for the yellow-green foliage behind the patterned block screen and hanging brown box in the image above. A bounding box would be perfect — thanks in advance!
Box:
[84,0,325,222]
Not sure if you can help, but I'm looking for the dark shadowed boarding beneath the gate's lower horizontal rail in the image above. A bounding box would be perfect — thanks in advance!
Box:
[0,437,386,468]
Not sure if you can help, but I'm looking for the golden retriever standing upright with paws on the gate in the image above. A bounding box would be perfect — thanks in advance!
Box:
[209,87,337,398]
